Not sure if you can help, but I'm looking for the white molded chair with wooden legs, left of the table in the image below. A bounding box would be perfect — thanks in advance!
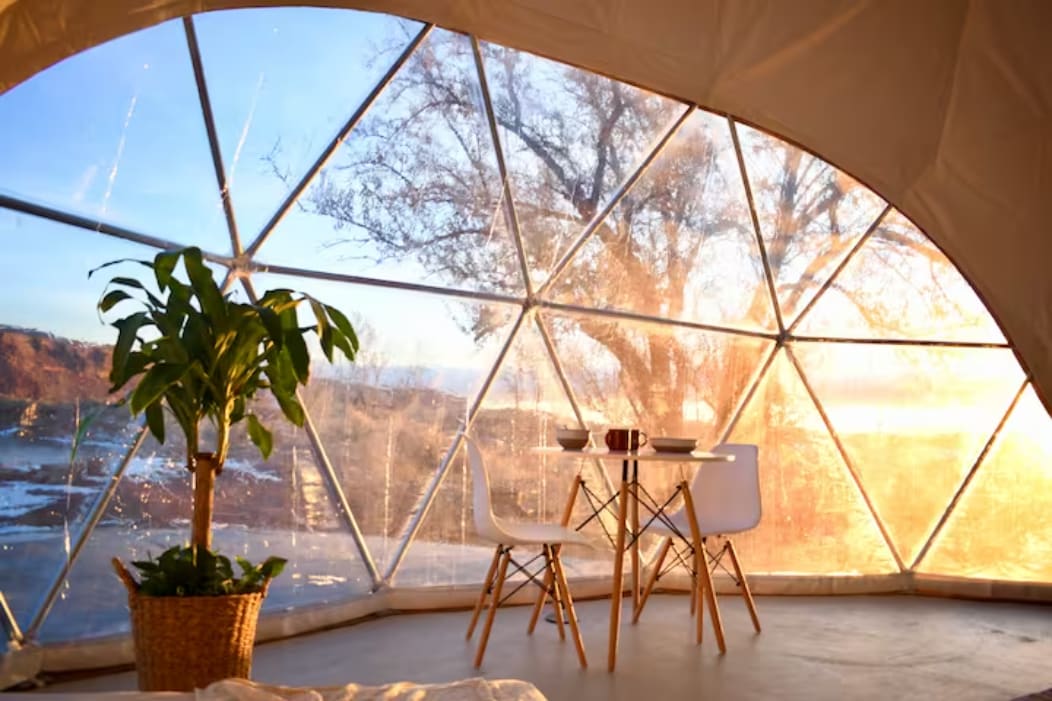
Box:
[464,435,588,668]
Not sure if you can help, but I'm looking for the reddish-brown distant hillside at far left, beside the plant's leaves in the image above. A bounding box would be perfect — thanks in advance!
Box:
[0,324,110,402]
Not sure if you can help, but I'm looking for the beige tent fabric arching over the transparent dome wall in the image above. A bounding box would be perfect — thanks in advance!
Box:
[0,0,1052,407]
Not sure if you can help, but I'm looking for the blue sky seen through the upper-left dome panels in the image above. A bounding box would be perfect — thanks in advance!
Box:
[0,8,491,365]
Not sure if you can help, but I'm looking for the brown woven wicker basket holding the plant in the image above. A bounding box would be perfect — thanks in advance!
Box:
[114,558,266,692]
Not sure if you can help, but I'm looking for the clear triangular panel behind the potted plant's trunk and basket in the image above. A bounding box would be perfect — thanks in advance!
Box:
[40,399,372,642]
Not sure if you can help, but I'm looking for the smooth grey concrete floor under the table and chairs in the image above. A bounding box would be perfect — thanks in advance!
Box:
[32,596,1052,701]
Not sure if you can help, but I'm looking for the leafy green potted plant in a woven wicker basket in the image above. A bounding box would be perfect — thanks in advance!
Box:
[89,247,358,690]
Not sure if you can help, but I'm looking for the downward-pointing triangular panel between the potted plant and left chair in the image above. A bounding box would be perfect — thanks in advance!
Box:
[252,275,520,569]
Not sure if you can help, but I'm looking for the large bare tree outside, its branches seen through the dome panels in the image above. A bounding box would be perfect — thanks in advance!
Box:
[308,31,934,434]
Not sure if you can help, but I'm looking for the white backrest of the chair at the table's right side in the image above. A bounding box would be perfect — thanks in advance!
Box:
[690,443,762,535]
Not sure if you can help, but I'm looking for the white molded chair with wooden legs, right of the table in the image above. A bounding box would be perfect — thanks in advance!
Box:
[634,443,763,653]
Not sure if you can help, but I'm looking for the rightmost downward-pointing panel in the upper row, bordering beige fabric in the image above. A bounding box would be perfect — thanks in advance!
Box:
[736,124,885,326]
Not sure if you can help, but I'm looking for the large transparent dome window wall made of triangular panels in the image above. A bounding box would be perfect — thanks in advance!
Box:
[0,2,1052,666]
